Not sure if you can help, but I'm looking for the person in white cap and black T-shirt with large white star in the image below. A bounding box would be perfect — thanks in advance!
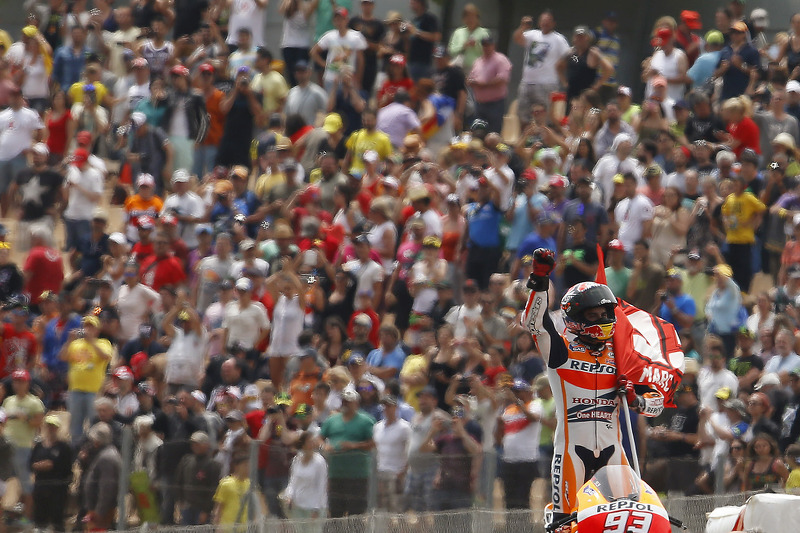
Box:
[9,143,64,251]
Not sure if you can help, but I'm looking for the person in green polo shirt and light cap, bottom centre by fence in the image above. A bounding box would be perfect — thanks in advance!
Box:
[320,388,375,518]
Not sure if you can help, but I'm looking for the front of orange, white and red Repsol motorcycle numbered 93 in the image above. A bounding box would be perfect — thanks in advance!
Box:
[545,465,686,533]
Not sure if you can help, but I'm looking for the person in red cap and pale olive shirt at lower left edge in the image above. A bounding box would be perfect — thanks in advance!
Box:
[3,369,44,518]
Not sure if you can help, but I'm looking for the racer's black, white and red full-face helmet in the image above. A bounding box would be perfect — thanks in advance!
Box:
[561,281,617,342]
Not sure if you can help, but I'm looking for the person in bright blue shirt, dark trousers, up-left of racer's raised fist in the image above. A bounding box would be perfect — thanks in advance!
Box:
[462,176,500,290]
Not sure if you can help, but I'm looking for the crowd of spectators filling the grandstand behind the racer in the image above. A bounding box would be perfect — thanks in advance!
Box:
[0,0,800,531]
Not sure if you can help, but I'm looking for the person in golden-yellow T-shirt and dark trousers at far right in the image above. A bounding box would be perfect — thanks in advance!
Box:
[722,176,767,292]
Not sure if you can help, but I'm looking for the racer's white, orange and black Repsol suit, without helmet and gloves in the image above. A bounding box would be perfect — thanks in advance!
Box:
[521,292,663,513]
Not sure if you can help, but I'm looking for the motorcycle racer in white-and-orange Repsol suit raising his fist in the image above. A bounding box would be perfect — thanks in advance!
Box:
[521,248,664,520]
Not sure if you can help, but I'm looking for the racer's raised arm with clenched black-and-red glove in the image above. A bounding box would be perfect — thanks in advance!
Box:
[520,248,567,368]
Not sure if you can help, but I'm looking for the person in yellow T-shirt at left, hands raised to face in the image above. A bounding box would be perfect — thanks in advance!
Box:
[58,315,114,445]
